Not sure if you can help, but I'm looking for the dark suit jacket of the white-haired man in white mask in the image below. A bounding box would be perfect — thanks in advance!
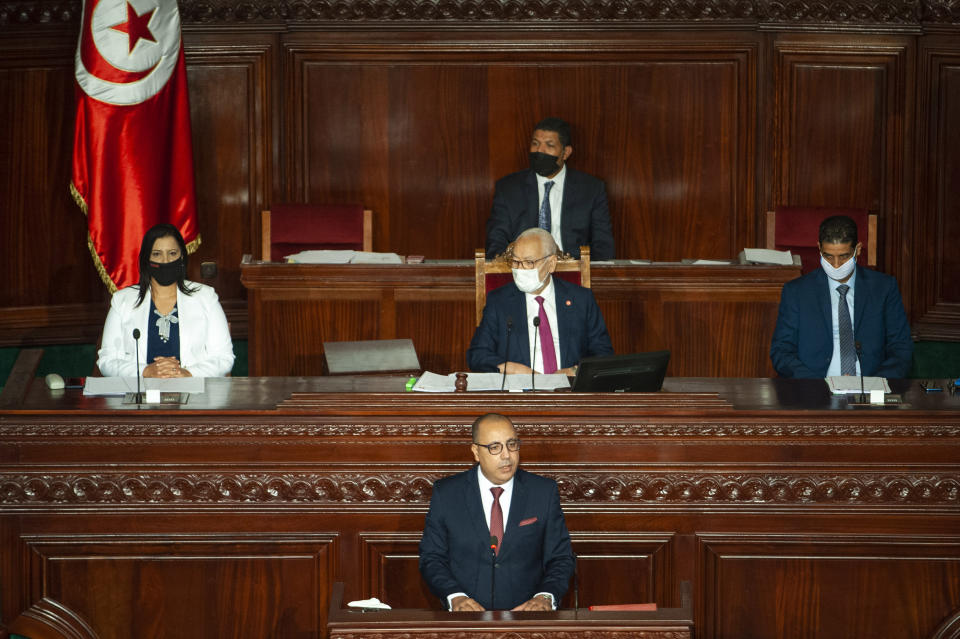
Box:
[467,277,613,373]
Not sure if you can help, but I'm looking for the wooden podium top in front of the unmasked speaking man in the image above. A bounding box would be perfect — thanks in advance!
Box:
[327,581,693,639]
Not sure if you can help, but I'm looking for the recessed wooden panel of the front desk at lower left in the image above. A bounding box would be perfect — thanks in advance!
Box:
[22,518,337,639]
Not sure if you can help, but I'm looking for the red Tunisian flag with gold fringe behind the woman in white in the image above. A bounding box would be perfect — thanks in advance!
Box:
[70,0,200,292]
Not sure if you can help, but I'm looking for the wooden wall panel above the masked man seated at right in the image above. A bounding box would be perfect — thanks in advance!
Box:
[771,34,913,278]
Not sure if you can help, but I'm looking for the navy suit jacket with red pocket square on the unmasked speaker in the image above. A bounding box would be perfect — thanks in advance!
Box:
[420,466,573,610]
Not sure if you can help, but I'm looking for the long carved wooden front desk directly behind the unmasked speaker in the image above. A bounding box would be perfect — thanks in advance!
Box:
[0,377,960,639]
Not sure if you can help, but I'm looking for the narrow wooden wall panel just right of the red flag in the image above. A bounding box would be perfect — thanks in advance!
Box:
[184,32,275,304]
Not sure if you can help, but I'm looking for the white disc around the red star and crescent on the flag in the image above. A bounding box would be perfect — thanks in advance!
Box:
[75,0,180,106]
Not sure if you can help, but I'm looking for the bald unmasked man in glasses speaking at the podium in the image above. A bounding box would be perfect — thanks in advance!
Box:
[420,413,573,612]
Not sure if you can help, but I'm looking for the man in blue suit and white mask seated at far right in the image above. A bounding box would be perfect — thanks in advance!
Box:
[770,215,913,378]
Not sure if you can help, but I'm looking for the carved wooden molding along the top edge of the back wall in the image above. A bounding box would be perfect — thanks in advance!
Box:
[0,0,960,28]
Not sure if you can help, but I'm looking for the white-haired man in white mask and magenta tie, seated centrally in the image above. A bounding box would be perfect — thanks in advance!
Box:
[467,228,613,375]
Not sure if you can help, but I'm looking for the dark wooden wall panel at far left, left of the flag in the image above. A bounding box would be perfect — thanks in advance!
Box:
[0,35,106,316]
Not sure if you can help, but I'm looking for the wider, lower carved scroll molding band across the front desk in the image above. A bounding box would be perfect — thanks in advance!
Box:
[0,471,960,507]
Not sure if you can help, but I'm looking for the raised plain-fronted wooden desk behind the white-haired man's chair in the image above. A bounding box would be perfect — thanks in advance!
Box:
[240,261,800,377]
